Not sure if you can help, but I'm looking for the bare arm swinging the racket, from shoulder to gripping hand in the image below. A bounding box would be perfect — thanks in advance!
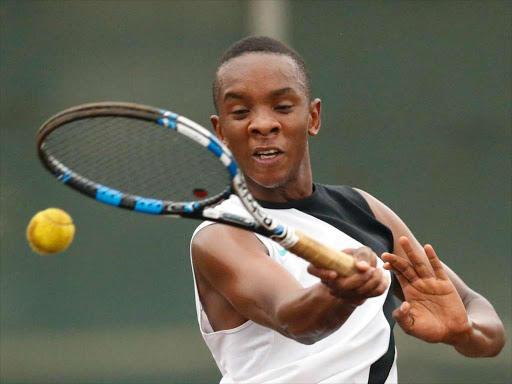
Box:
[192,224,386,344]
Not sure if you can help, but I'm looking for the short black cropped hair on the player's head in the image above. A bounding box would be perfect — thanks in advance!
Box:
[212,36,313,113]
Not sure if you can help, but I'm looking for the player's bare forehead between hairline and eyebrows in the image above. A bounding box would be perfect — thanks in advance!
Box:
[218,52,304,99]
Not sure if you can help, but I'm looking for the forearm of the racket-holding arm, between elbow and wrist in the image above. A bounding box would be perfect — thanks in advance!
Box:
[276,283,363,344]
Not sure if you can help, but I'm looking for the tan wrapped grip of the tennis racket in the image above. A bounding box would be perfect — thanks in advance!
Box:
[288,230,357,276]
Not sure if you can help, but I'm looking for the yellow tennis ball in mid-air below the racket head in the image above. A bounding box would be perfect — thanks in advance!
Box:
[27,208,75,255]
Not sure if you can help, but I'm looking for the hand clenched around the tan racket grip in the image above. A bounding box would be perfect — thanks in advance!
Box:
[308,247,388,305]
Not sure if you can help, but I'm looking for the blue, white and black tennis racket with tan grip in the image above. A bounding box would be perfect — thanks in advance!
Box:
[37,102,356,276]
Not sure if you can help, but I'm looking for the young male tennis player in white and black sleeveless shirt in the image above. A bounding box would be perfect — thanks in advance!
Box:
[191,37,505,383]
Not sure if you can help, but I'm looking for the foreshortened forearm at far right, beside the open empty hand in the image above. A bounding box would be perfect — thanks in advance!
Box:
[452,293,505,357]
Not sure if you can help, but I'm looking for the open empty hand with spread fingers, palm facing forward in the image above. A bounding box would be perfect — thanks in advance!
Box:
[382,237,470,345]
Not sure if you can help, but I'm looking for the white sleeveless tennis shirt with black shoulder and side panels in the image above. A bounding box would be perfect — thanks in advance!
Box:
[192,184,397,384]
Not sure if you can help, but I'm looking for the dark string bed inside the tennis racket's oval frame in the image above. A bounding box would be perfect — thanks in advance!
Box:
[43,117,230,202]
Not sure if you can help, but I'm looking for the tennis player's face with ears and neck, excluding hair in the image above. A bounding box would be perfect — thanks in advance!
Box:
[211,53,320,194]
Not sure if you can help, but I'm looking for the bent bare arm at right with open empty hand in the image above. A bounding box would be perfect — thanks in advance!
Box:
[354,191,505,357]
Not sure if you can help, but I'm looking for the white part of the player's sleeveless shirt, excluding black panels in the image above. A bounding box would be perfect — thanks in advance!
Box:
[190,196,397,383]
